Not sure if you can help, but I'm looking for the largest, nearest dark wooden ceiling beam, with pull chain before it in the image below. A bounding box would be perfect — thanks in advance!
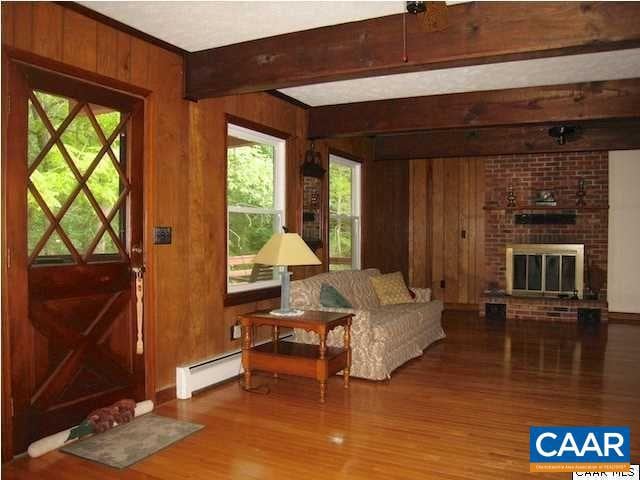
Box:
[185,2,640,100]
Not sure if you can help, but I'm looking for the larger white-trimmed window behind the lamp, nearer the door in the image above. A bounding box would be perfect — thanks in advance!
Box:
[227,124,286,293]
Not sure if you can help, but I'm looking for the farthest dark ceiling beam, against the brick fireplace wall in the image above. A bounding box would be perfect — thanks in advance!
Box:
[375,118,640,160]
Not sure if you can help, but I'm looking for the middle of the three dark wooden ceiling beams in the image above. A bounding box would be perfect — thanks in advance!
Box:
[309,78,640,138]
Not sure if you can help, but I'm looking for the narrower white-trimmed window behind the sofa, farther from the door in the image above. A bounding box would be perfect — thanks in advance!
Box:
[329,155,361,270]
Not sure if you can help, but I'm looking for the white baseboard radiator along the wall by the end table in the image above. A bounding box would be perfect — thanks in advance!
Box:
[176,333,292,400]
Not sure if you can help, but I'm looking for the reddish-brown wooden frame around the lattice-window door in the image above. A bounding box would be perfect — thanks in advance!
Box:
[0,46,156,462]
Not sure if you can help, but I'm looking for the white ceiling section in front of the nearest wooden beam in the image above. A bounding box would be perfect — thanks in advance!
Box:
[80,1,405,52]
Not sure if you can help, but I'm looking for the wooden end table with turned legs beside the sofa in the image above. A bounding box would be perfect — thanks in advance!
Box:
[240,310,353,403]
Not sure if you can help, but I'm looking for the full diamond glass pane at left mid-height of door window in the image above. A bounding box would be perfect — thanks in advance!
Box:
[30,145,78,215]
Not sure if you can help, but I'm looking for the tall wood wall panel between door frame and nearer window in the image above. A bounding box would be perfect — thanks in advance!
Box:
[149,46,191,389]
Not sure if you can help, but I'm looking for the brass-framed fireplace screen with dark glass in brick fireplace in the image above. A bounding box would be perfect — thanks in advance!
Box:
[506,244,584,298]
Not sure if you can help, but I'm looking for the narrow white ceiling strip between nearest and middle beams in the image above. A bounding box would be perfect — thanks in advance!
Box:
[280,48,640,107]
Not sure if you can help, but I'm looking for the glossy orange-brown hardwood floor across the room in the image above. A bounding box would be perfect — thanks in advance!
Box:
[2,312,640,480]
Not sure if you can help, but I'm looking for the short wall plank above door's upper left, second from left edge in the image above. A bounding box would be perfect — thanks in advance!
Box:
[33,2,63,61]
